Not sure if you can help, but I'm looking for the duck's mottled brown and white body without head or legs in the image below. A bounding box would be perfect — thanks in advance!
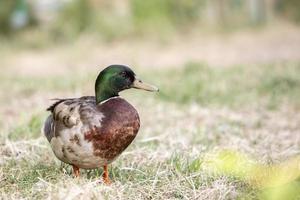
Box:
[44,97,140,168]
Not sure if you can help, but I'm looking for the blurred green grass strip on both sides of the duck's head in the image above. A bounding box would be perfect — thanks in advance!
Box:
[0,63,300,109]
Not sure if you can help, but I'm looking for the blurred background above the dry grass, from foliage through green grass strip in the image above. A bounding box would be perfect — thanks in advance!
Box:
[0,0,300,111]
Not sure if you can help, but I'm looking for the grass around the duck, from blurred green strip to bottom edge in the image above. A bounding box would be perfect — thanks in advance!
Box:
[0,63,300,200]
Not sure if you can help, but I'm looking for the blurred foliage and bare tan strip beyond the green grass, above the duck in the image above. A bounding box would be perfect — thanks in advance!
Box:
[0,0,300,72]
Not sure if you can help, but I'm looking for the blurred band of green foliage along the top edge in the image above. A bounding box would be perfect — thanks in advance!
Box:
[0,0,300,41]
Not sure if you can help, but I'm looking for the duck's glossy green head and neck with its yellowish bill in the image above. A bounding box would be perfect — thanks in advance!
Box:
[95,65,158,104]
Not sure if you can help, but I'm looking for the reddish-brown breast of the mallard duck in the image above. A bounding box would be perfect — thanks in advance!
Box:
[84,98,140,161]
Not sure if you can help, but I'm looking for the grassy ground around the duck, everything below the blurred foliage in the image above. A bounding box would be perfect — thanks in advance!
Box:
[0,26,300,199]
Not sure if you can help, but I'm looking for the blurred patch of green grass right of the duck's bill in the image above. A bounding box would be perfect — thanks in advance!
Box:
[142,63,300,109]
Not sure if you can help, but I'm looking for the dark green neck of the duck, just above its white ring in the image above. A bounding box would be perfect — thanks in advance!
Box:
[95,80,119,104]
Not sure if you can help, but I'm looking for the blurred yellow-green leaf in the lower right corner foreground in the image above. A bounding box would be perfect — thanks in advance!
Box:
[203,150,300,200]
